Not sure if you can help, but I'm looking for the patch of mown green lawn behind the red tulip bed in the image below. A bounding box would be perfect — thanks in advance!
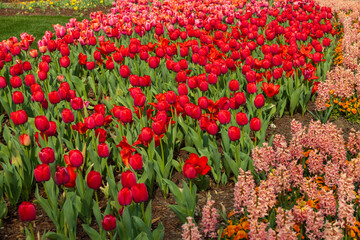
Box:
[0,16,82,42]
